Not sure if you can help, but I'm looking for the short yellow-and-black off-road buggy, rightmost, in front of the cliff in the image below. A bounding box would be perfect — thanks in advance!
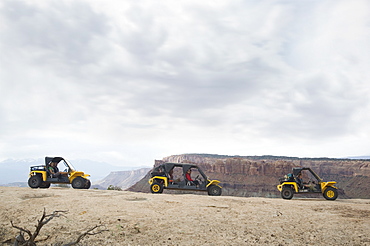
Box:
[277,167,338,200]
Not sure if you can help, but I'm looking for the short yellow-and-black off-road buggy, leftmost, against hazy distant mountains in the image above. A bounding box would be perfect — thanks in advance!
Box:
[28,157,91,189]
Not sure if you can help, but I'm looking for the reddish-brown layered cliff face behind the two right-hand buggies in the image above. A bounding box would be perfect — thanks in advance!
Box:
[129,154,370,198]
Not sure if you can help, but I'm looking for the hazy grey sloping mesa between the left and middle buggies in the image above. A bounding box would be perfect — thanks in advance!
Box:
[92,168,151,190]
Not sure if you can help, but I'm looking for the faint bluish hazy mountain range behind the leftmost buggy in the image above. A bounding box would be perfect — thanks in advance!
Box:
[0,158,150,185]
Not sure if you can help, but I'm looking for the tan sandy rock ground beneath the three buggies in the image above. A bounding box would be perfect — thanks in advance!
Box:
[0,187,370,245]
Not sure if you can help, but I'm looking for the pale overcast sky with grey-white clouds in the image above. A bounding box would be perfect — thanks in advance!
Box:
[0,0,370,166]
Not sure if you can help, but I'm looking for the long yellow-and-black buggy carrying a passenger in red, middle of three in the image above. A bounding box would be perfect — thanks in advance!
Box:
[149,163,222,196]
